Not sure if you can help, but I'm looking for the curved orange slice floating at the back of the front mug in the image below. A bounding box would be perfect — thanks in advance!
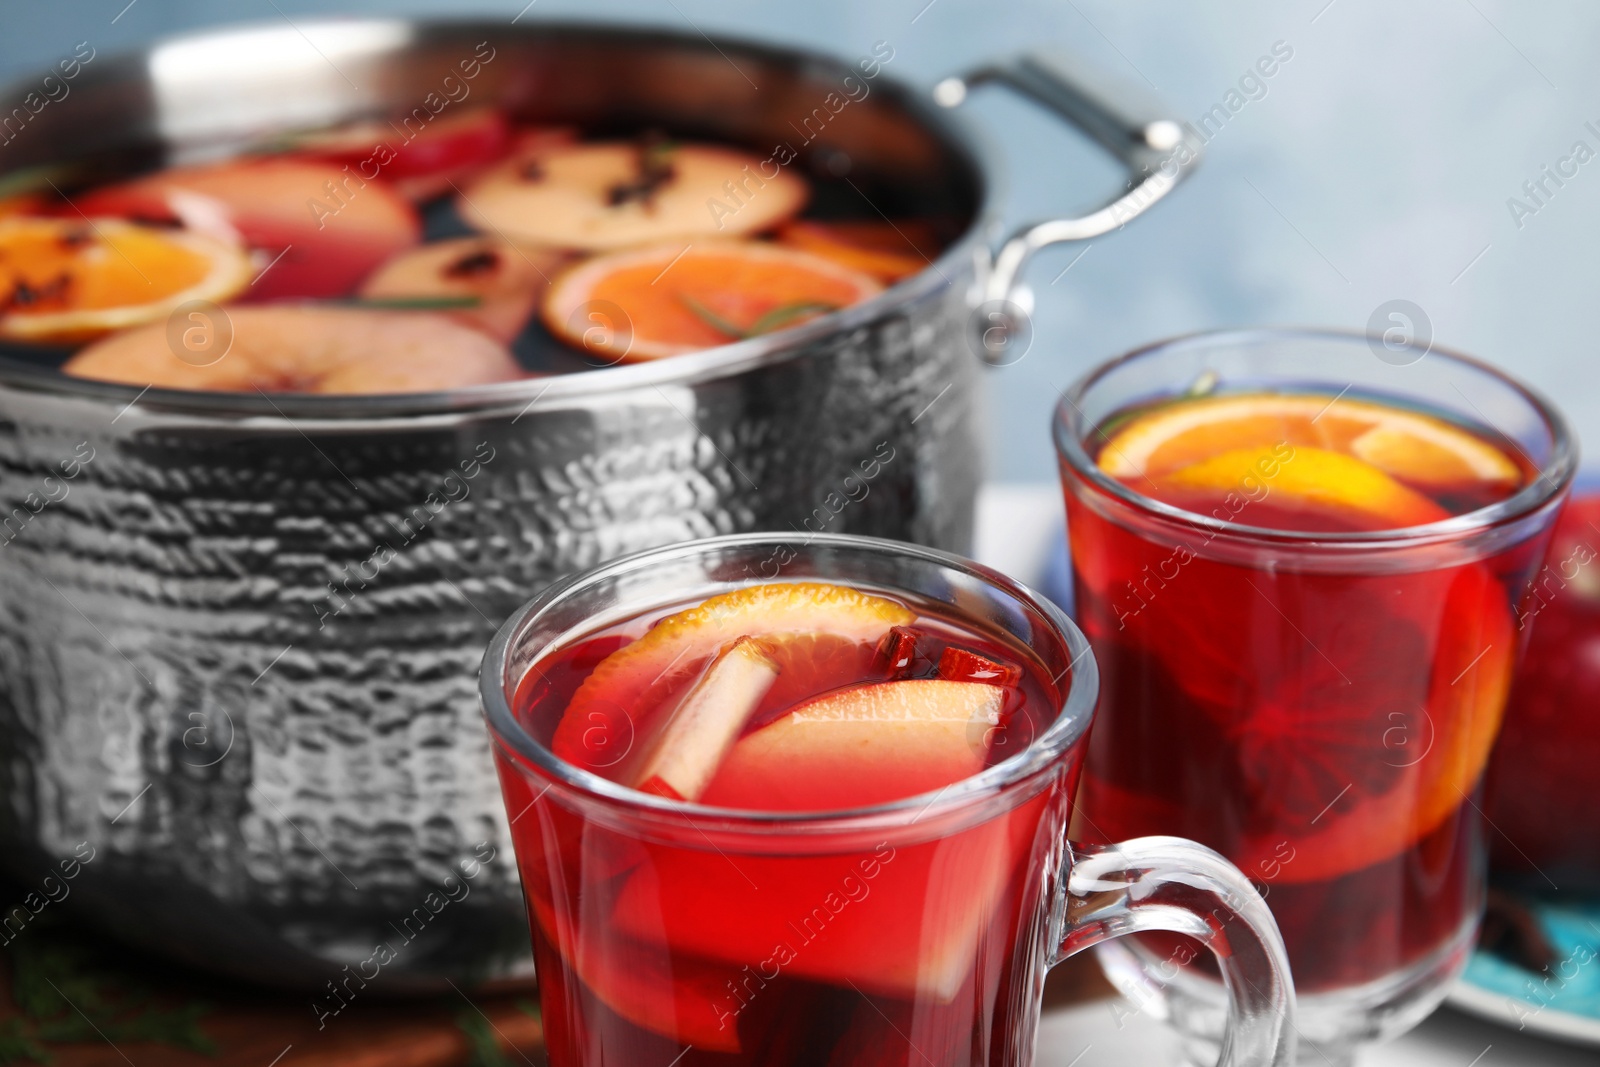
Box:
[550,582,915,781]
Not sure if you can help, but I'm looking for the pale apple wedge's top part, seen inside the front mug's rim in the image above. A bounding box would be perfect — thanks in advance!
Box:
[701,680,1005,811]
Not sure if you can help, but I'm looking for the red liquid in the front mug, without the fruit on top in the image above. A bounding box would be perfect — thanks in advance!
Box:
[499,591,1078,1067]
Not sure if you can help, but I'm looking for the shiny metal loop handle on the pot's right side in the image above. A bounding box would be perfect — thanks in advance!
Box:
[933,53,1203,363]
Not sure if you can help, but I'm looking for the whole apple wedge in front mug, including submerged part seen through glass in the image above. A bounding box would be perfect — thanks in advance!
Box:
[611,680,1017,1000]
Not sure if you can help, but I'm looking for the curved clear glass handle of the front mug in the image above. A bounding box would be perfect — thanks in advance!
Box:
[1051,837,1296,1067]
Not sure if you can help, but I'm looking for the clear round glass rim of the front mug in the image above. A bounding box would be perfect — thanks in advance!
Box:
[478,533,1099,833]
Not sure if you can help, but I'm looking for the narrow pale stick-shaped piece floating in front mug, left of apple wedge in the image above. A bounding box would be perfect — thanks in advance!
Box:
[640,637,778,800]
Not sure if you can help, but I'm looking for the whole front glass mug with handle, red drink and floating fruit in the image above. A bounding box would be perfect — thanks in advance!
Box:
[483,536,1290,1067]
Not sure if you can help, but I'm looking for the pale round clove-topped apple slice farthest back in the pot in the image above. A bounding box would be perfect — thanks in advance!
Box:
[461,141,810,251]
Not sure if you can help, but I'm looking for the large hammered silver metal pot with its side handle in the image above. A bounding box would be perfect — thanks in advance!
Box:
[0,21,1195,992]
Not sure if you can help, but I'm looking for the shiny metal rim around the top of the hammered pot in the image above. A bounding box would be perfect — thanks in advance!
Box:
[0,16,1000,424]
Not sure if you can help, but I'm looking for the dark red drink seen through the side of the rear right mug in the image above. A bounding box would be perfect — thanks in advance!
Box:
[1066,395,1544,992]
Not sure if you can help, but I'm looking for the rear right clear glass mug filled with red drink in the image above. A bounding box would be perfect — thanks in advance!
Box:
[1054,330,1574,1064]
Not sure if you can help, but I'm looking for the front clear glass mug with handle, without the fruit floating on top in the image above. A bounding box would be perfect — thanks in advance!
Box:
[480,534,1294,1067]
